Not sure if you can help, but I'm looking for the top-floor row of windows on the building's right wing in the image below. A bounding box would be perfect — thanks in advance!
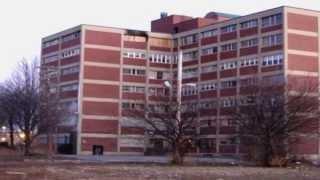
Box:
[181,14,282,43]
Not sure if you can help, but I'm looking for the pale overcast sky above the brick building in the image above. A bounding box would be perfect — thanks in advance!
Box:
[0,0,320,82]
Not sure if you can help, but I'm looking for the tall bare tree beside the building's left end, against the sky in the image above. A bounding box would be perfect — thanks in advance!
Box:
[1,60,64,155]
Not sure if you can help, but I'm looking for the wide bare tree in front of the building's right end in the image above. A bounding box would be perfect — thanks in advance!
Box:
[230,77,319,166]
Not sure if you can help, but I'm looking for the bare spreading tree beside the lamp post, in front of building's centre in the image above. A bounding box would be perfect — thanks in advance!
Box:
[129,101,198,165]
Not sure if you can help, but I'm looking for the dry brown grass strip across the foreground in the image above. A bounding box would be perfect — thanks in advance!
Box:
[0,161,320,180]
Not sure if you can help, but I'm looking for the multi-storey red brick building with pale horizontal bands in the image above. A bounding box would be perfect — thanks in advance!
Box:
[41,7,320,157]
